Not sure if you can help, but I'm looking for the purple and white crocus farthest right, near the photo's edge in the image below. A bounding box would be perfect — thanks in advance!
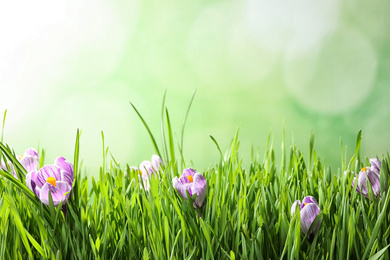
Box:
[352,158,381,198]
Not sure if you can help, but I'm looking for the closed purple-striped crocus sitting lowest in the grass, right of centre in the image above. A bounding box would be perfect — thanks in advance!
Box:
[291,196,321,239]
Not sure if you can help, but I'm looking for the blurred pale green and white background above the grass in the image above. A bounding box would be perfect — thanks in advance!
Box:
[0,0,390,175]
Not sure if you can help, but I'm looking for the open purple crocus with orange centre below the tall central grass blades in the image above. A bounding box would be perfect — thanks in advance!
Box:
[173,168,207,208]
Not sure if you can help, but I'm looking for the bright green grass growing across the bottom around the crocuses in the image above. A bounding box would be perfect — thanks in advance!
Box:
[0,98,390,259]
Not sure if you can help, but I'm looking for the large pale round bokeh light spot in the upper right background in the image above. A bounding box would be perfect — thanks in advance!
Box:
[283,27,377,114]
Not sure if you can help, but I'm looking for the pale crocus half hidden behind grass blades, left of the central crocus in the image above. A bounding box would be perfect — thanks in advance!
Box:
[130,154,164,191]
